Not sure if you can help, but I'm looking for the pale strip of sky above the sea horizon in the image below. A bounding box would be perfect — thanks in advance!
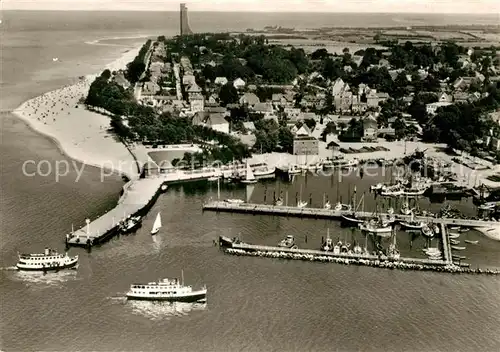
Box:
[0,0,500,13]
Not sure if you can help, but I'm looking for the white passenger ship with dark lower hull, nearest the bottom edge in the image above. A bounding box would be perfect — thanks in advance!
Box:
[127,275,207,302]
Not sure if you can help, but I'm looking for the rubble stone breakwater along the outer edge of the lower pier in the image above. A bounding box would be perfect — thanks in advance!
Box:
[224,248,500,275]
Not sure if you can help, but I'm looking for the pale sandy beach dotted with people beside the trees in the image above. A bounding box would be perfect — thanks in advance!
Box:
[13,47,140,178]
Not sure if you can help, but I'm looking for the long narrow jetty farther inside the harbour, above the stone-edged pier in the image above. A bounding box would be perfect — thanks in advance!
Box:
[203,200,499,227]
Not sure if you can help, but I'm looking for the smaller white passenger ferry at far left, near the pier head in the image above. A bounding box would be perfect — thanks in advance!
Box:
[16,248,78,271]
